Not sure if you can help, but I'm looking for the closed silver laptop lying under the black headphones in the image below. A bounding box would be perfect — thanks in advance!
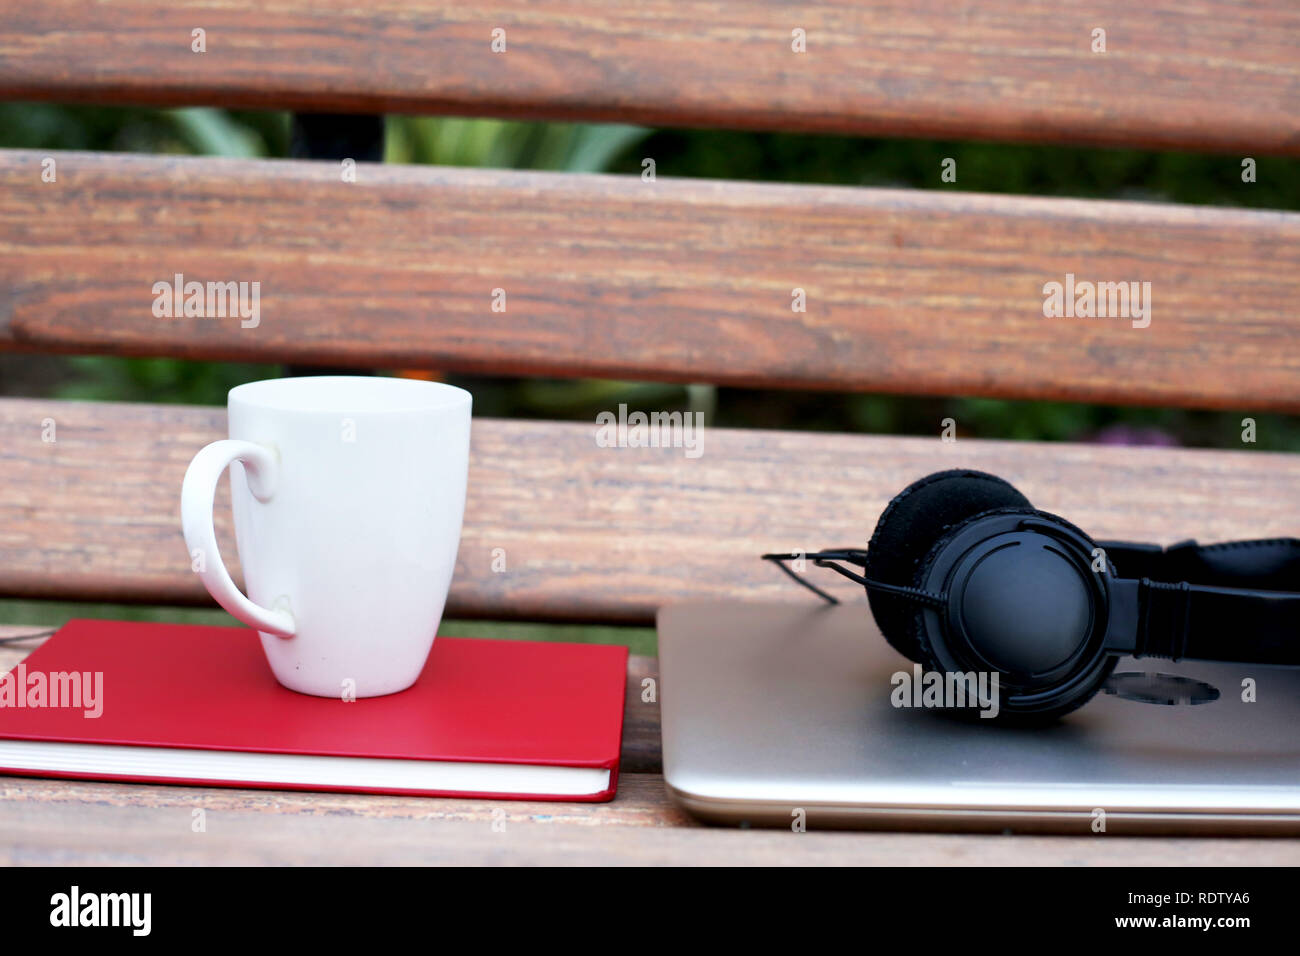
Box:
[658,598,1300,834]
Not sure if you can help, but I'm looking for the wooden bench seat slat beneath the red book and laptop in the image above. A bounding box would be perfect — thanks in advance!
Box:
[0,626,1300,866]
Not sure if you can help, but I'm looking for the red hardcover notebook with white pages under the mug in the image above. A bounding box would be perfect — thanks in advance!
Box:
[0,620,628,801]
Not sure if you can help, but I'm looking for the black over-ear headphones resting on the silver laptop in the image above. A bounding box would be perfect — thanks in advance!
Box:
[763,470,1300,721]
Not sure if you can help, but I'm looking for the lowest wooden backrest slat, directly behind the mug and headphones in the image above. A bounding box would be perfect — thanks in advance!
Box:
[0,399,1300,623]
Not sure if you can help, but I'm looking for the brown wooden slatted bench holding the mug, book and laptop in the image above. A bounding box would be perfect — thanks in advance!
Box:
[0,0,1300,865]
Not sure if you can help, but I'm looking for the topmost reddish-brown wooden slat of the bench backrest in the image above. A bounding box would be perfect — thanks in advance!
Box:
[0,0,1300,155]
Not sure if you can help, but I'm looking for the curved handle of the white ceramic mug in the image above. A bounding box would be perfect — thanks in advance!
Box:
[181,438,296,637]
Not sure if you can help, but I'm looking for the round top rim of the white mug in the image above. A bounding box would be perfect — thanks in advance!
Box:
[226,375,472,414]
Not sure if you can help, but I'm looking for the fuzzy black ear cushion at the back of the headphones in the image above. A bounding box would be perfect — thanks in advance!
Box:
[866,468,1032,663]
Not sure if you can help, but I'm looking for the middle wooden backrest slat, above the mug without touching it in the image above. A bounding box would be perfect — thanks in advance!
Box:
[0,152,1300,412]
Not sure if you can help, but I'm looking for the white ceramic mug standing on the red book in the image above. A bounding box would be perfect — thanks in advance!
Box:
[181,376,471,697]
